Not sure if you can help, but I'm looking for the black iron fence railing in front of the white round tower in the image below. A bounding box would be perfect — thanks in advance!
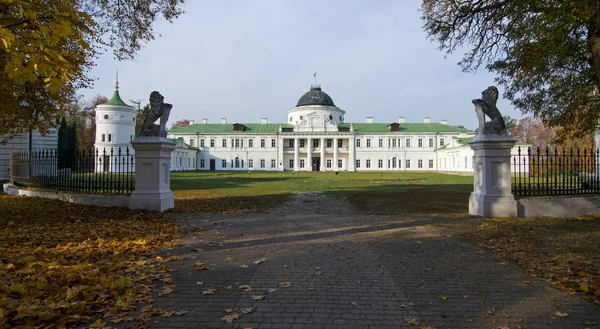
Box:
[10,148,135,194]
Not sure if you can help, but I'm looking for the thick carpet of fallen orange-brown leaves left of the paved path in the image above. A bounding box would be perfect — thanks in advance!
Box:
[0,194,180,328]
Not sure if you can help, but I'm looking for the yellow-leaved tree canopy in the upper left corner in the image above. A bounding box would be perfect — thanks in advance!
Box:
[0,0,185,139]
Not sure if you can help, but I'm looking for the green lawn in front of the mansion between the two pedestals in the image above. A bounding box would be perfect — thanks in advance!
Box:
[171,172,473,214]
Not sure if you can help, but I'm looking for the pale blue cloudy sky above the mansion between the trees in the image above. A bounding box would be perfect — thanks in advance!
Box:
[80,0,521,129]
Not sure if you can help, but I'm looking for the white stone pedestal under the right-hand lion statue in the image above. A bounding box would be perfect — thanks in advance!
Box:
[469,135,517,217]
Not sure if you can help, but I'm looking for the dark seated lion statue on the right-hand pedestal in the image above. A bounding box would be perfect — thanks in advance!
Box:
[473,86,506,135]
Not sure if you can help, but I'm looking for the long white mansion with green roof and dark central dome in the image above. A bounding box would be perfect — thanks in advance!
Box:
[168,85,516,172]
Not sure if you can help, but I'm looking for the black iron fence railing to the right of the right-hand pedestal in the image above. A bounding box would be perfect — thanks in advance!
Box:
[512,147,600,196]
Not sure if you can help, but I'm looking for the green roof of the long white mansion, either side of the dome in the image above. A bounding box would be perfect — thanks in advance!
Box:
[169,123,472,134]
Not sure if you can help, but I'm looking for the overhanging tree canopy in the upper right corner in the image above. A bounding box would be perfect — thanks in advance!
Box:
[421,0,600,135]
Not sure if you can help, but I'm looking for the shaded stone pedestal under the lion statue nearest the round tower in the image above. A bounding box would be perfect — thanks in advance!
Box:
[129,136,175,212]
